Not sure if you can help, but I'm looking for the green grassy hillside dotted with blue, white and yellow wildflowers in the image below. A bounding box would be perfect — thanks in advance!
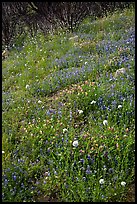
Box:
[2,9,135,202]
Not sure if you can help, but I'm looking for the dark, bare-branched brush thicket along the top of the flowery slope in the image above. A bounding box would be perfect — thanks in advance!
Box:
[2,1,134,45]
